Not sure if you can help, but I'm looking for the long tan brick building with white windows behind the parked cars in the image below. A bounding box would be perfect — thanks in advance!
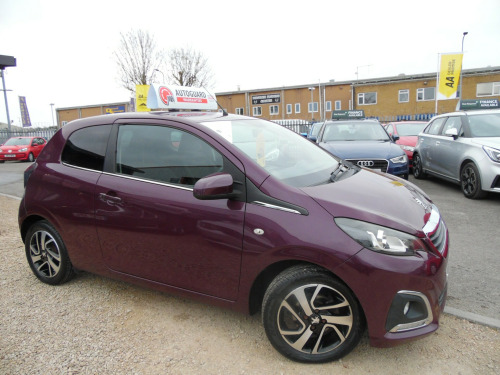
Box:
[216,67,500,122]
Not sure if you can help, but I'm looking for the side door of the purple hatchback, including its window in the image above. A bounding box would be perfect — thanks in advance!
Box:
[95,124,245,300]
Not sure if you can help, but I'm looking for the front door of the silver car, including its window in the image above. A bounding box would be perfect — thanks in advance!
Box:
[434,116,463,180]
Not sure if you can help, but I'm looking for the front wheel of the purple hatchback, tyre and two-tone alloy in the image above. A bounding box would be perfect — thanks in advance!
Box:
[262,265,364,363]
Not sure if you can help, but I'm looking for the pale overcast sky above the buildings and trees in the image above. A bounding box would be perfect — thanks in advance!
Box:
[0,0,500,126]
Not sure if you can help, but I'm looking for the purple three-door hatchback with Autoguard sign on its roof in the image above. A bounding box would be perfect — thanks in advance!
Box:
[19,86,449,362]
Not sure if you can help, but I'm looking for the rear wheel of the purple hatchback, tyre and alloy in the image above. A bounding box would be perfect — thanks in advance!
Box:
[24,220,74,285]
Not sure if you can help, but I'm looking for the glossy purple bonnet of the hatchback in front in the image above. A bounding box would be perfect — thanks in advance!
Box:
[302,169,432,236]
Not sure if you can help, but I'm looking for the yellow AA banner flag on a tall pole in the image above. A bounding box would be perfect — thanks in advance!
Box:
[437,53,463,100]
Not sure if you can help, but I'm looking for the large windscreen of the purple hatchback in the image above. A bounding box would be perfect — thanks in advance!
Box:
[203,119,338,187]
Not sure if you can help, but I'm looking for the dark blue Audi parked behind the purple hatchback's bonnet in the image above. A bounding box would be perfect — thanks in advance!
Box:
[316,120,409,179]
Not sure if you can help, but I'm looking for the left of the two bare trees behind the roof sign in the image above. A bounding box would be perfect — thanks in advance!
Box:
[113,30,165,92]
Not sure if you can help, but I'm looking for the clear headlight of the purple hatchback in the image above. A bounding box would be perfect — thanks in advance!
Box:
[335,218,427,255]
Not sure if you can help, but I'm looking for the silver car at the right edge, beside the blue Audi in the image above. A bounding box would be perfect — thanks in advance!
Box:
[413,109,500,199]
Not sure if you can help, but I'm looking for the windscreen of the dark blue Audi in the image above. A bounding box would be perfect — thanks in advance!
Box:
[322,121,389,142]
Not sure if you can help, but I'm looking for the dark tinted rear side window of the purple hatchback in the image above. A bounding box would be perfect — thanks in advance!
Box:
[61,125,111,171]
